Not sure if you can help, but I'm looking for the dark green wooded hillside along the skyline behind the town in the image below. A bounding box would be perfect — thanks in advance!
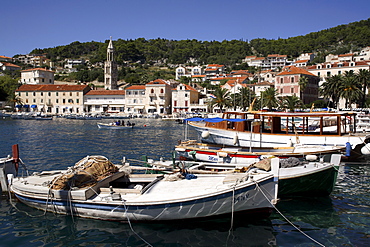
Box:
[31,18,370,66]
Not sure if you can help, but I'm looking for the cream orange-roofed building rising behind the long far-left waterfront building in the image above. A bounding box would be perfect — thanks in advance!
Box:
[20,68,54,84]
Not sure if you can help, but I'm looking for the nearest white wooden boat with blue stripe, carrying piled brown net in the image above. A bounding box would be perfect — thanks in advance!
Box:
[10,156,278,221]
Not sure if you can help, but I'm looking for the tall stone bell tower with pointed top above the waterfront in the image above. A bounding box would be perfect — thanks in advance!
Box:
[104,37,118,90]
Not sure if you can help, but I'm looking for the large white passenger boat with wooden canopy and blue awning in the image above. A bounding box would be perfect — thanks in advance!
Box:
[187,112,370,157]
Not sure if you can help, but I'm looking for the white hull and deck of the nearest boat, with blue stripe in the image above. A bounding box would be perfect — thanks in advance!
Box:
[12,174,277,221]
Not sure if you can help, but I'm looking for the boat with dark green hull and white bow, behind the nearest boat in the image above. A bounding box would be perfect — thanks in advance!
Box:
[169,154,341,198]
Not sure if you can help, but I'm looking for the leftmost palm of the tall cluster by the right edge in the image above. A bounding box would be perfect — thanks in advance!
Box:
[319,75,343,108]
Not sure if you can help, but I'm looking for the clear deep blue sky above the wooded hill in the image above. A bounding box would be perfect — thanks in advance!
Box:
[0,0,370,57]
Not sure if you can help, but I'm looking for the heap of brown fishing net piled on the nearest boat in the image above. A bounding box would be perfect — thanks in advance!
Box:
[49,156,118,190]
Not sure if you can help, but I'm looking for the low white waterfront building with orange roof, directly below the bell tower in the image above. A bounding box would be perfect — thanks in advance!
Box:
[84,90,126,114]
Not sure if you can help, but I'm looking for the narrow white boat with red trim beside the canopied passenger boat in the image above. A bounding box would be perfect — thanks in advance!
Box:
[175,140,345,165]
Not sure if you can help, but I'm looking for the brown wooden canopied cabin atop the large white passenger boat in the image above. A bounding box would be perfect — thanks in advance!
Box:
[206,112,356,136]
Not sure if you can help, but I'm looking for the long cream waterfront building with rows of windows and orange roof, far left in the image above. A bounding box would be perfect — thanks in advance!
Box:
[15,84,90,114]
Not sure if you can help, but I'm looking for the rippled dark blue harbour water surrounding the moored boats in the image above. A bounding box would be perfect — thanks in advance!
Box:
[0,119,370,246]
